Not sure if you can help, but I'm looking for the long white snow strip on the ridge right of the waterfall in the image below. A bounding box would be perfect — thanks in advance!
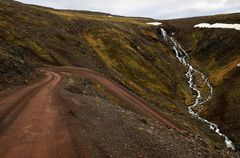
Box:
[194,23,240,30]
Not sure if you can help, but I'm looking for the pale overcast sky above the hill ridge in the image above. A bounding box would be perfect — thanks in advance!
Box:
[15,0,240,19]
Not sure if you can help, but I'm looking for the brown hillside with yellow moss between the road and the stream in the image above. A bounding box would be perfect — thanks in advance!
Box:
[0,1,191,117]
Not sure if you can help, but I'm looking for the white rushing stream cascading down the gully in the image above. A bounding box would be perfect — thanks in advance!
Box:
[161,28,235,150]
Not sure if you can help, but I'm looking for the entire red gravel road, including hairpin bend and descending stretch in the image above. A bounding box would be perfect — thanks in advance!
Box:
[0,67,179,158]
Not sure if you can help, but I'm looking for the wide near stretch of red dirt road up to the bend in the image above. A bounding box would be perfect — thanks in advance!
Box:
[0,72,76,158]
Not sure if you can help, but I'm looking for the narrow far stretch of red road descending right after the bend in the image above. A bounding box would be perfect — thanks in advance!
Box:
[51,67,180,130]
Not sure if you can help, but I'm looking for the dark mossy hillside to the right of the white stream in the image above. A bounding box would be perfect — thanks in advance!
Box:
[163,13,240,148]
